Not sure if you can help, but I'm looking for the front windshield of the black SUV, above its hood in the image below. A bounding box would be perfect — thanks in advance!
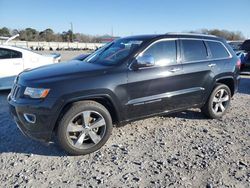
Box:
[84,39,143,65]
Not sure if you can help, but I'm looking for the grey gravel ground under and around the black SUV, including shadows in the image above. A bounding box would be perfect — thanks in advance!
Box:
[0,71,250,188]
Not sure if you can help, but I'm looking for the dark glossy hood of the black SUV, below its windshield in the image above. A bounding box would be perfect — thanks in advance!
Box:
[18,60,110,83]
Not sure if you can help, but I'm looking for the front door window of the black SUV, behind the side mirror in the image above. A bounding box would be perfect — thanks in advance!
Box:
[143,40,176,66]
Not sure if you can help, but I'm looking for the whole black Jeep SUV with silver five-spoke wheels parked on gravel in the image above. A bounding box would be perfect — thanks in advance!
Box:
[8,33,240,155]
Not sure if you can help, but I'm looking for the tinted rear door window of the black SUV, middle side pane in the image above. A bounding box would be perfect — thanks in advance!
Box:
[182,40,208,61]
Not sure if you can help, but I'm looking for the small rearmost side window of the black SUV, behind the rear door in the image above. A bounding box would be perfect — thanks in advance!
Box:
[207,41,230,59]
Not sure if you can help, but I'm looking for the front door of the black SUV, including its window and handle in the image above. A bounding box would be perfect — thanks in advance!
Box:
[126,39,183,119]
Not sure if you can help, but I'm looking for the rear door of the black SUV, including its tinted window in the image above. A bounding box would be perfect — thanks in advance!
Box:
[180,39,214,107]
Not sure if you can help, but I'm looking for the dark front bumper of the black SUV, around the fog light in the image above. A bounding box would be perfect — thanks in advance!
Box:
[7,96,61,142]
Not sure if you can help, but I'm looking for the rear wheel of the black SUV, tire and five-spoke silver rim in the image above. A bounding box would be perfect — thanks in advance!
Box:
[201,84,231,119]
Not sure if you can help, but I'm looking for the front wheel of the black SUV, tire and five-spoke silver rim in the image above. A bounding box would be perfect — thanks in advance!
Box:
[57,101,113,155]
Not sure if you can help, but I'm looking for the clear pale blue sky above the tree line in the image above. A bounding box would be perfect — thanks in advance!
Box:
[0,0,250,38]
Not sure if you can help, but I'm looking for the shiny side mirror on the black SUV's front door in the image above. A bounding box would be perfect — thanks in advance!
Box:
[132,55,155,70]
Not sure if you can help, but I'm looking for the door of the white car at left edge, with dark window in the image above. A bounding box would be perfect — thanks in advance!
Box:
[0,48,23,89]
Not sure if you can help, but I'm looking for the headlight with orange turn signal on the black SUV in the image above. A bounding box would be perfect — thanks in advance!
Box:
[24,87,50,99]
